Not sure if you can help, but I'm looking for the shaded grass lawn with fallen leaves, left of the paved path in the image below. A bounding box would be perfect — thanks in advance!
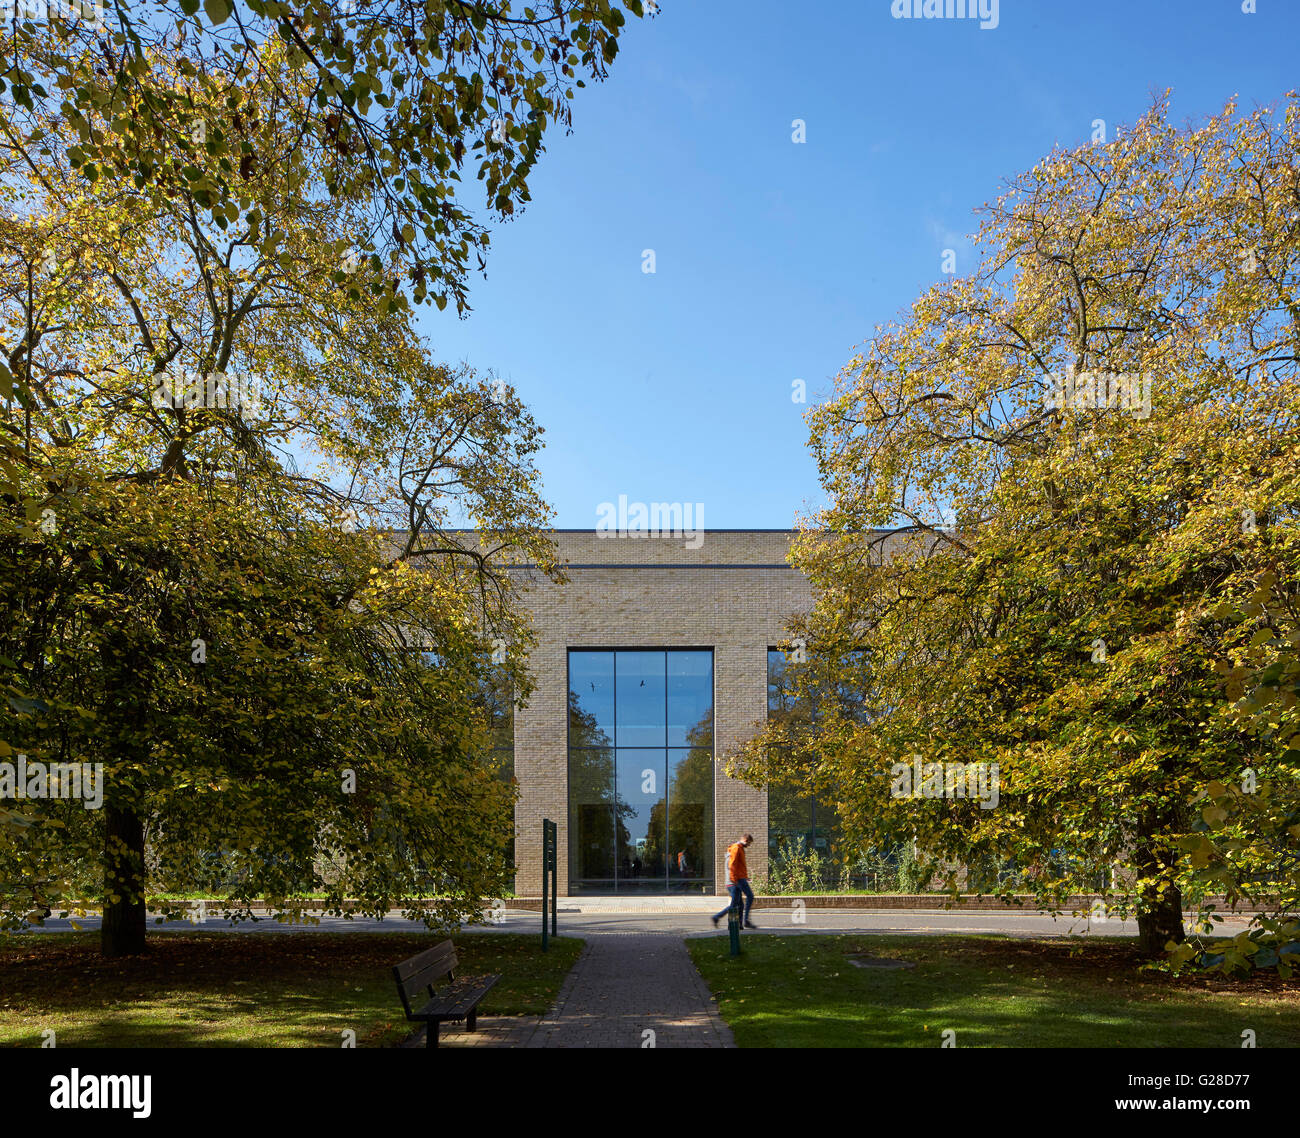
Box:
[0,931,582,1047]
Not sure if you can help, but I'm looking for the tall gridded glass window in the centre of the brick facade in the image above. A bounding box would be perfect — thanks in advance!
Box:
[568,649,714,893]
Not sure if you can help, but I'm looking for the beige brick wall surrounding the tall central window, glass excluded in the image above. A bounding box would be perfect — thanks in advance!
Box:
[515,531,811,896]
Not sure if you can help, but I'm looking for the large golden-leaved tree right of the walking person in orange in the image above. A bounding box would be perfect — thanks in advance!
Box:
[733,98,1300,952]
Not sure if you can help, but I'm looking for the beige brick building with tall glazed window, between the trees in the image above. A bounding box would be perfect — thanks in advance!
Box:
[514,529,811,895]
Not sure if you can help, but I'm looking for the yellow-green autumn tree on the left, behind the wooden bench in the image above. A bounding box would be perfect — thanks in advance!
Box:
[0,42,566,955]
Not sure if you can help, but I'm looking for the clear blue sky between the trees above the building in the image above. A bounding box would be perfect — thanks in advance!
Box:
[420,0,1300,528]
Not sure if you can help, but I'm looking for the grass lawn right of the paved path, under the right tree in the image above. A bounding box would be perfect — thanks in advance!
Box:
[686,934,1300,1047]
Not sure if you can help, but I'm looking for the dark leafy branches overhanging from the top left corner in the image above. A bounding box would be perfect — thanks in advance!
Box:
[0,0,642,310]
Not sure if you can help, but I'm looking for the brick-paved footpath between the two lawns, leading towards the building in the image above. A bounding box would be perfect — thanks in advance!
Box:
[407,934,736,1047]
